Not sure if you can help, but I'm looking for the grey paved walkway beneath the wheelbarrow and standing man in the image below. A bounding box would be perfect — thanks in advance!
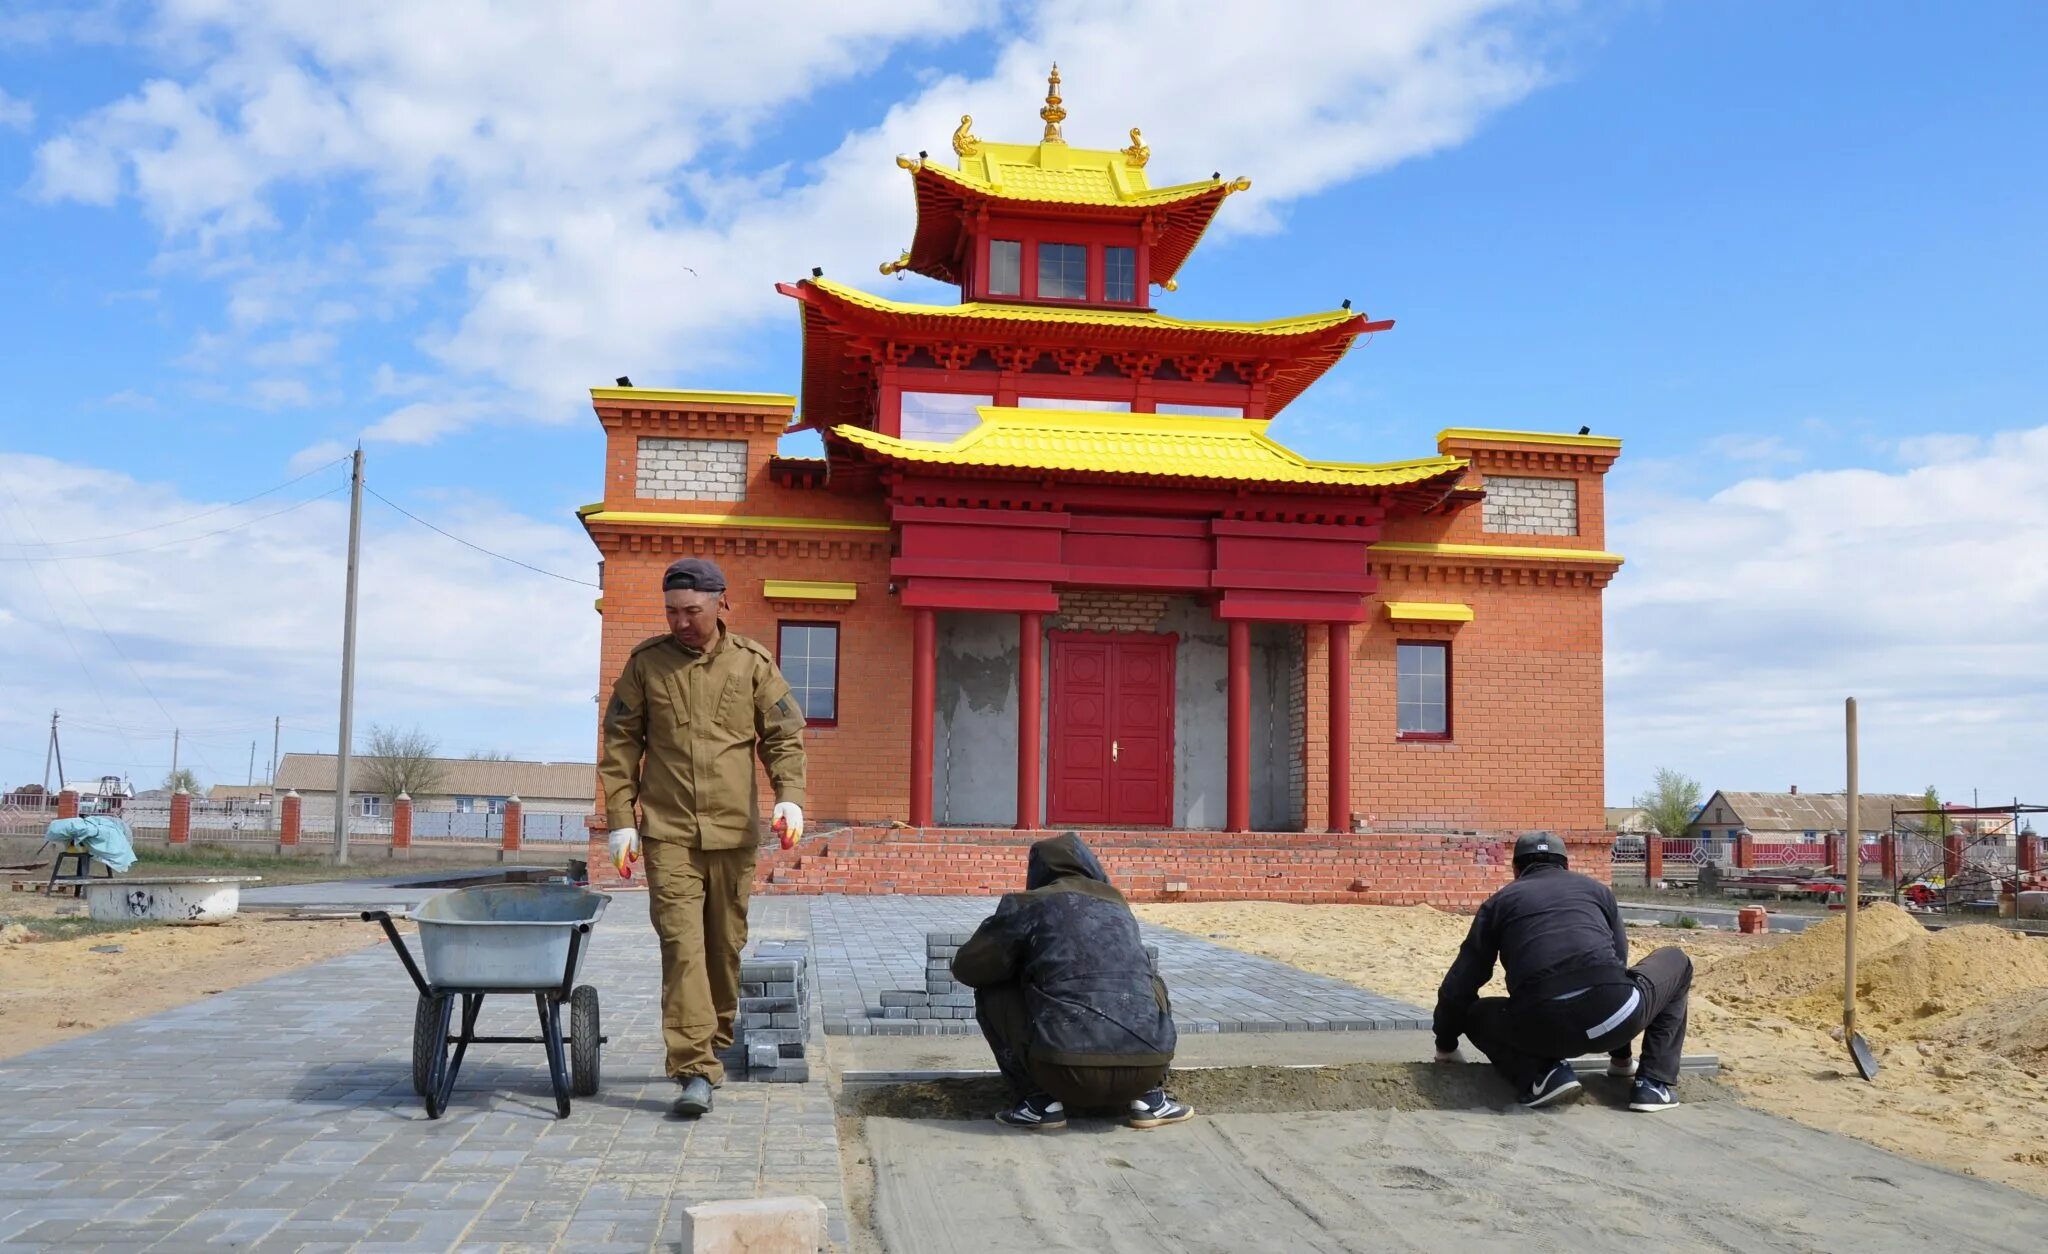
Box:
[0,893,846,1252]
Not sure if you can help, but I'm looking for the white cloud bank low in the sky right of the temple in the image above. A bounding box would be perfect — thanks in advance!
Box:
[1608,426,2048,797]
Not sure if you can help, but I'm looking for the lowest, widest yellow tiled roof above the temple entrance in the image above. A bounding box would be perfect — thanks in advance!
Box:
[834,406,1466,488]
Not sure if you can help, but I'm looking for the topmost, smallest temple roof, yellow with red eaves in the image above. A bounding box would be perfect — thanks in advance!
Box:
[883,139,1251,285]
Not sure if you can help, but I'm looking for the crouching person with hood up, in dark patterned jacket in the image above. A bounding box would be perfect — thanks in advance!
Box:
[952,832,1194,1129]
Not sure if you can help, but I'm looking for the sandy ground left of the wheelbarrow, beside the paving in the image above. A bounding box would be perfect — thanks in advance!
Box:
[0,893,383,1057]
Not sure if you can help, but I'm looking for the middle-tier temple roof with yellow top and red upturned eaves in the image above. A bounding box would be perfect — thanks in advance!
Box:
[780,279,1393,428]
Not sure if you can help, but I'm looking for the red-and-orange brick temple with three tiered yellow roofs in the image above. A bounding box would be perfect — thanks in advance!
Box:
[580,74,1622,901]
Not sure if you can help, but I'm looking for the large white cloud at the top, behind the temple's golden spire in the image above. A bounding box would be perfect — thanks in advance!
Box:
[37,0,1544,438]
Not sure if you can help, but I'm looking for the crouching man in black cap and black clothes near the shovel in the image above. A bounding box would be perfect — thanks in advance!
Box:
[1436,832,1692,1111]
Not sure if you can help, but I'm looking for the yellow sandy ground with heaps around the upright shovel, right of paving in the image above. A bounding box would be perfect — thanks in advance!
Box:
[1137,904,2048,1197]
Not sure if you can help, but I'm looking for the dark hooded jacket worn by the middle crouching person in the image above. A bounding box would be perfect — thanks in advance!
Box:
[952,832,1178,1068]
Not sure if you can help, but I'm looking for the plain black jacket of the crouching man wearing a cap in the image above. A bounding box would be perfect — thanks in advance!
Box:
[1434,863,1628,1049]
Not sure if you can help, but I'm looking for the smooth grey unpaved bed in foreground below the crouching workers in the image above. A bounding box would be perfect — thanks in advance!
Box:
[854,1102,2048,1254]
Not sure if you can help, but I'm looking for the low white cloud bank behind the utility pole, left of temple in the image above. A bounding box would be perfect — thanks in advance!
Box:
[0,455,598,787]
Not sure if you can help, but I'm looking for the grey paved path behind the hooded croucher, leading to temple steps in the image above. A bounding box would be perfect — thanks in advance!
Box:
[798,897,1430,1037]
